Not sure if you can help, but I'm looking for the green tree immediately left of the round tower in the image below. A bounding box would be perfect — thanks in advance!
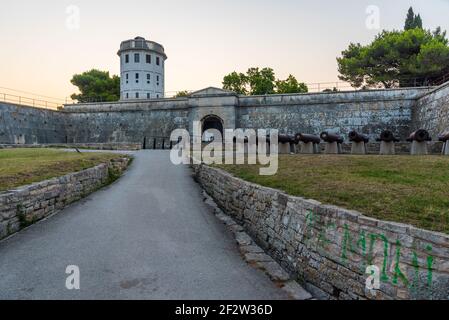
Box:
[70,69,120,102]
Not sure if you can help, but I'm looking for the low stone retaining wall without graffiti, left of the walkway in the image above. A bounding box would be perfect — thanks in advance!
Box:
[0,158,129,239]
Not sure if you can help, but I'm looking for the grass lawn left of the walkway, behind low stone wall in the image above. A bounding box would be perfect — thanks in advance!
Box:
[0,148,129,191]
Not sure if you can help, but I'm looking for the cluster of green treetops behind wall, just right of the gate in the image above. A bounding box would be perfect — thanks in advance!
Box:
[223,68,308,95]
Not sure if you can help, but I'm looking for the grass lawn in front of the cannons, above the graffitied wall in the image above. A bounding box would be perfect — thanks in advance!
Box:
[214,155,449,233]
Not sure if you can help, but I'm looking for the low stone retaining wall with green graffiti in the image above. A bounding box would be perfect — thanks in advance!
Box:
[194,165,449,299]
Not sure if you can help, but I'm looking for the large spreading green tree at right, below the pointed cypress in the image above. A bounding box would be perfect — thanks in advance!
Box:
[337,28,449,88]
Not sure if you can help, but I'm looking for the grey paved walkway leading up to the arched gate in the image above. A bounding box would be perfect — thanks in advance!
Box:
[0,151,287,299]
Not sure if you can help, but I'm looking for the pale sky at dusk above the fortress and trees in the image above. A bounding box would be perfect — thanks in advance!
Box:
[0,0,449,98]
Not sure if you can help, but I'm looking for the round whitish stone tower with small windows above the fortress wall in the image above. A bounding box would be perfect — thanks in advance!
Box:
[117,37,167,100]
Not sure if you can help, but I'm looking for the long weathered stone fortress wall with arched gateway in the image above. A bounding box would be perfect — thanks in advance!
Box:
[0,84,449,145]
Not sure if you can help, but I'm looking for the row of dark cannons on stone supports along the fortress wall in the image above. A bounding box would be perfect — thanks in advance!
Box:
[278,129,449,155]
